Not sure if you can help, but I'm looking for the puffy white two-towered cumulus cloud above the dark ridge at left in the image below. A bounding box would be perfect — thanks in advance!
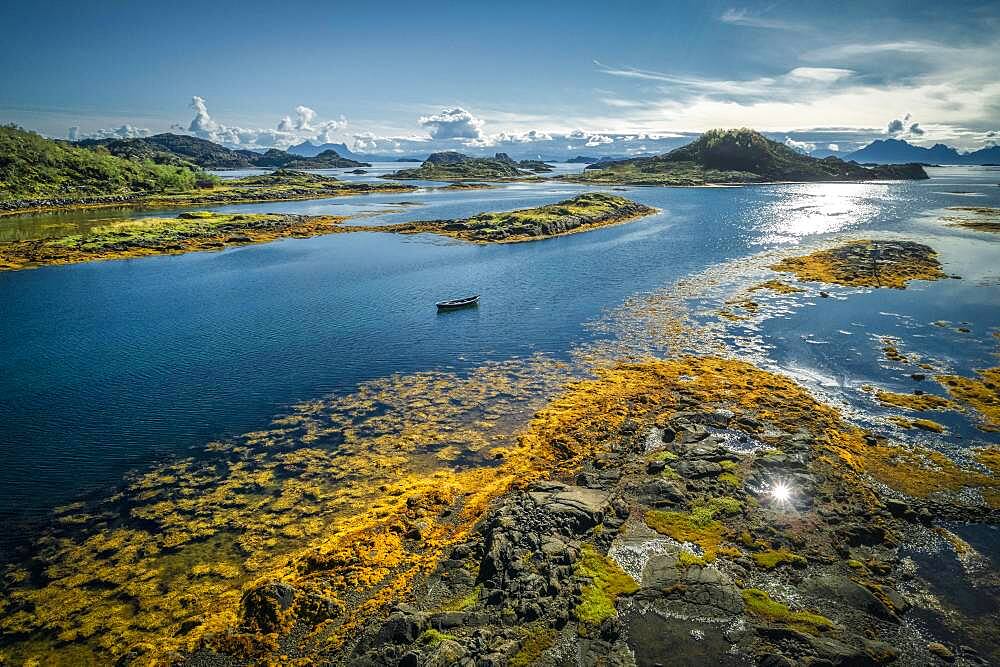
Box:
[178,95,347,148]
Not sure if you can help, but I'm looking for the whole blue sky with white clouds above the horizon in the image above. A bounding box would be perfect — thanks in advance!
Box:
[0,0,1000,155]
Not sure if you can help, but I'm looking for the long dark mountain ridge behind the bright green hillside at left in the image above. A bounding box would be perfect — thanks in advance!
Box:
[77,133,371,169]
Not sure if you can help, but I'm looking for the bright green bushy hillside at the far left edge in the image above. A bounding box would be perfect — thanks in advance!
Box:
[0,125,216,201]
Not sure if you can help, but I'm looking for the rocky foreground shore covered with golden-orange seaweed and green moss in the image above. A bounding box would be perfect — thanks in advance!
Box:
[0,231,1000,667]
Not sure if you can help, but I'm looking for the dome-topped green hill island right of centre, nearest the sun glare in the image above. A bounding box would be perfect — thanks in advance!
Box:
[572,128,927,185]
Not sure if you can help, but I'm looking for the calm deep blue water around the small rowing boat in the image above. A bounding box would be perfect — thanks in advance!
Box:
[0,168,1000,560]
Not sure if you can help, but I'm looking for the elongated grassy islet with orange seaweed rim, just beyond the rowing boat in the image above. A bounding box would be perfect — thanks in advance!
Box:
[372,192,656,243]
